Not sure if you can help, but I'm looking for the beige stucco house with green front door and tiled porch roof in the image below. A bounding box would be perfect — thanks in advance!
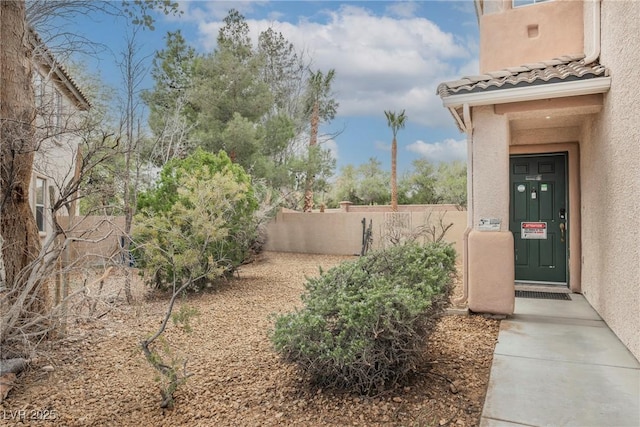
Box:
[438,0,640,358]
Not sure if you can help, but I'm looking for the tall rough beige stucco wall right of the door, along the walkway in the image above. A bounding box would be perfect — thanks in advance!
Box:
[580,0,640,359]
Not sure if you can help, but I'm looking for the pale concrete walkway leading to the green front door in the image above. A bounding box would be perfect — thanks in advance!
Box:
[480,294,640,427]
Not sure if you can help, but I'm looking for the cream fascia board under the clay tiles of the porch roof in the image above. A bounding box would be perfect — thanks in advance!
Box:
[442,77,611,109]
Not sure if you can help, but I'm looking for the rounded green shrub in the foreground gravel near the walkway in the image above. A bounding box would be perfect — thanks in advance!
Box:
[271,243,455,394]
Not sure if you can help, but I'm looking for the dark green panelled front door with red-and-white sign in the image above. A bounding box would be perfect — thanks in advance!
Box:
[509,154,569,283]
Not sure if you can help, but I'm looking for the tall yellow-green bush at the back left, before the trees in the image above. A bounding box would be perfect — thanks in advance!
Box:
[133,150,258,290]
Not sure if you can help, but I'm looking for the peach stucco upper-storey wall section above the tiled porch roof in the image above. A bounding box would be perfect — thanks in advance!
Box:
[480,0,584,73]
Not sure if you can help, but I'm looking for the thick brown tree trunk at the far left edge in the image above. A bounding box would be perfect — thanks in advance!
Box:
[0,1,47,312]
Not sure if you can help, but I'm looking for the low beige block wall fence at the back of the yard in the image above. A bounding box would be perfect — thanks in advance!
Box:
[61,203,467,265]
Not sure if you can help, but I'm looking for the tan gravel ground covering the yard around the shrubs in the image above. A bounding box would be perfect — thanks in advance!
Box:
[0,252,498,426]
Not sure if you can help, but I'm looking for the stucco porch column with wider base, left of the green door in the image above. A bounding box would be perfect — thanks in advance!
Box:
[468,106,515,314]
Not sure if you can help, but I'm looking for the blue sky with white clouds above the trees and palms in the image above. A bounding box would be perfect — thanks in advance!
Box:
[62,0,478,171]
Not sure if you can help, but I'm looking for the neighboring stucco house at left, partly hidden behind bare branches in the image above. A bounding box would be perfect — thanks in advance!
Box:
[29,31,90,239]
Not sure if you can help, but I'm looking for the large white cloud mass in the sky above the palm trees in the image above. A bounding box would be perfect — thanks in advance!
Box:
[193,2,477,126]
